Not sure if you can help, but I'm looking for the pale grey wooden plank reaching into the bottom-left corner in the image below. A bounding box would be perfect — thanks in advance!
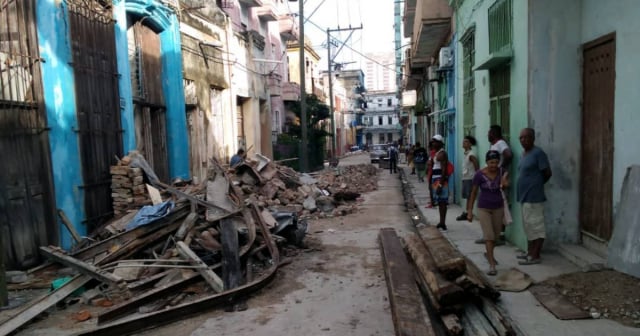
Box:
[0,275,91,335]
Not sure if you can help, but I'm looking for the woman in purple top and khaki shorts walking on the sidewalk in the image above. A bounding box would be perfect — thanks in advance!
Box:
[467,150,509,275]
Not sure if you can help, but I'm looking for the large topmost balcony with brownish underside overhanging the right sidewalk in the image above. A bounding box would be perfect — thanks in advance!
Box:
[411,0,452,67]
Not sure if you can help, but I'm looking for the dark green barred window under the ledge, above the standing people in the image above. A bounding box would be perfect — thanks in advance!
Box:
[489,64,511,142]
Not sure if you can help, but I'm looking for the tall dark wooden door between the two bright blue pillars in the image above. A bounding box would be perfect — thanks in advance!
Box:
[69,0,122,232]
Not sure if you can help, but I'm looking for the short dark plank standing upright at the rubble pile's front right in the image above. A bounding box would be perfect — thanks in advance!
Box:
[220,218,242,290]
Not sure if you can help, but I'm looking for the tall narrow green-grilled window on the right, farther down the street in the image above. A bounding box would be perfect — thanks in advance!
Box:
[460,28,476,135]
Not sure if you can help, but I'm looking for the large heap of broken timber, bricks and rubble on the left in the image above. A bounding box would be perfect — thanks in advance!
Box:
[0,151,377,335]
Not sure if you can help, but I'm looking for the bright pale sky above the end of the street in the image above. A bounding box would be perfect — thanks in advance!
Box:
[288,0,398,69]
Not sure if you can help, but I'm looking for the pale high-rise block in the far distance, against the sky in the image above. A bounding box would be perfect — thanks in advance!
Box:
[364,52,396,92]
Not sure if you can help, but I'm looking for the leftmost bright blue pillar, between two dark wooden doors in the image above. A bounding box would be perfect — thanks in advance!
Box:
[36,0,86,249]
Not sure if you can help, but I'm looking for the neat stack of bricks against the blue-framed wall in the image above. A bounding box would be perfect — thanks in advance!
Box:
[109,165,151,218]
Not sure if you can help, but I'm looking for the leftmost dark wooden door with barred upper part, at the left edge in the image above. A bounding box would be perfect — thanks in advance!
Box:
[0,0,58,270]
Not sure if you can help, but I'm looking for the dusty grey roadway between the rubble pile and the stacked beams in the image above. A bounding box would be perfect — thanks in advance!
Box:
[140,153,411,336]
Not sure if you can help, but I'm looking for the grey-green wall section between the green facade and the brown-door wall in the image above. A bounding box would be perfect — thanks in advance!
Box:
[528,0,582,243]
